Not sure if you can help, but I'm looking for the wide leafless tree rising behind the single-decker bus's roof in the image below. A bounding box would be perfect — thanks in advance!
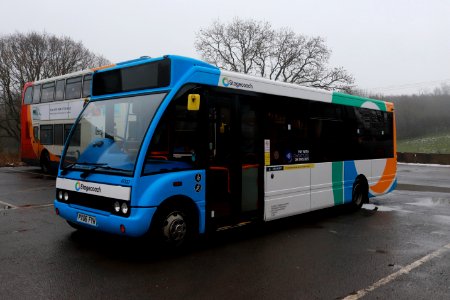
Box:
[195,18,354,91]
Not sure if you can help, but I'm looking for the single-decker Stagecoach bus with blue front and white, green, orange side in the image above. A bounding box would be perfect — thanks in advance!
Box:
[54,56,397,245]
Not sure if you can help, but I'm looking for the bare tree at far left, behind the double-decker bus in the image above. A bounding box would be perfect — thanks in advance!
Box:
[0,32,109,141]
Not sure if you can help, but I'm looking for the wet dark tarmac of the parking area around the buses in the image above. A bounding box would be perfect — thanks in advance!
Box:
[0,165,450,299]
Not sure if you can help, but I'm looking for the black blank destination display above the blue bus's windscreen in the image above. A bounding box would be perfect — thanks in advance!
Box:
[92,59,170,96]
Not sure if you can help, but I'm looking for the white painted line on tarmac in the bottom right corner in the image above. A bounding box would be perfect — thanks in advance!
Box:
[344,244,450,300]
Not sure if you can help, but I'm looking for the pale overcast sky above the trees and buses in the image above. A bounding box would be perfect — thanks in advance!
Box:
[0,0,450,94]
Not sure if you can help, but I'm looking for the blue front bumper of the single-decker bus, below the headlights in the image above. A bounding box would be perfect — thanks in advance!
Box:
[54,200,156,237]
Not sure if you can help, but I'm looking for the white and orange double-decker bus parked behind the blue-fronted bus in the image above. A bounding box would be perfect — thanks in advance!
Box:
[20,69,112,172]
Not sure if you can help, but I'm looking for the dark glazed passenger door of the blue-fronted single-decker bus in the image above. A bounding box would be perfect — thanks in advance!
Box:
[206,94,262,227]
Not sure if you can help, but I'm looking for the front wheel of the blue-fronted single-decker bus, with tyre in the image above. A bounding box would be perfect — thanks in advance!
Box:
[153,206,194,249]
